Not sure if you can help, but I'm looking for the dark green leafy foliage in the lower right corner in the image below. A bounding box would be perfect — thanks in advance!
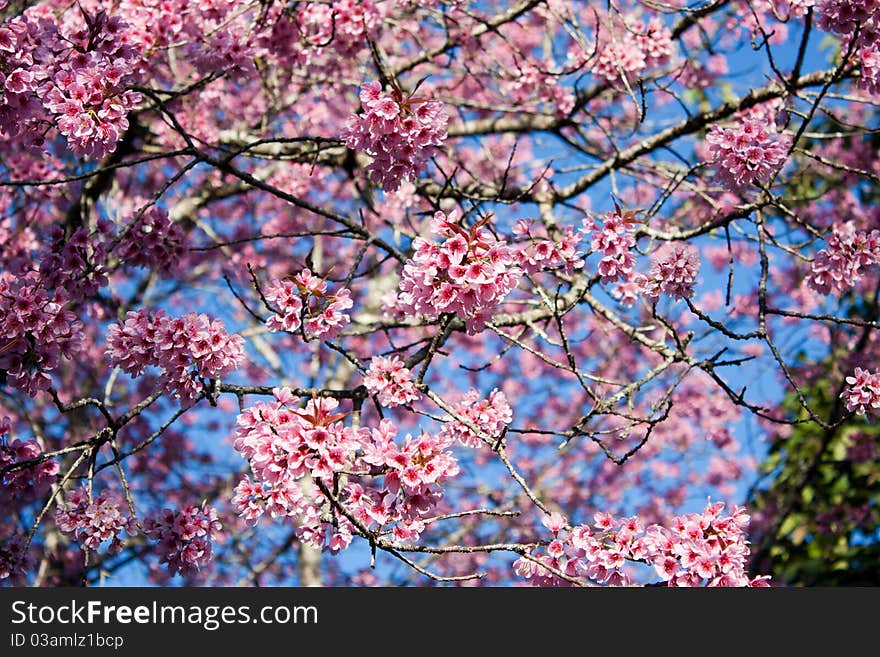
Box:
[750,379,880,586]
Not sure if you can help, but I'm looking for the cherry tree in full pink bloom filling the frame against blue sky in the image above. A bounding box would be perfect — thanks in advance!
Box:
[0,0,880,586]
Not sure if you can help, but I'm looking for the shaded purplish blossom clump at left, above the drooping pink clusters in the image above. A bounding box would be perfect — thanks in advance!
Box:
[115,205,186,275]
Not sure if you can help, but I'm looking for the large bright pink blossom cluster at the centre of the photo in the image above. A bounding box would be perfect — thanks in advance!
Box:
[392,212,523,334]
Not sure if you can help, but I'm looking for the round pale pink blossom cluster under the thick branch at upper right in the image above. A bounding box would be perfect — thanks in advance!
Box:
[706,111,791,191]
